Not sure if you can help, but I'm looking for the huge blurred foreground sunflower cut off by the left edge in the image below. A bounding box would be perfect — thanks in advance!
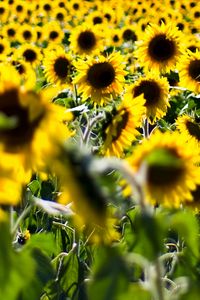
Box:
[0,65,72,175]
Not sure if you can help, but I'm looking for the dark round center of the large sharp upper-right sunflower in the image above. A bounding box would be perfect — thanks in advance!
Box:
[148,34,176,62]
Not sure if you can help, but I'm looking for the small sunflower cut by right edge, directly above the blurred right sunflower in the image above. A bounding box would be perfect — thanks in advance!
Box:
[176,115,200,149]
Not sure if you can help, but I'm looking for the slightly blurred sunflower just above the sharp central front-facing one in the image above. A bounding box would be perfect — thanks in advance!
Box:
[69,24,103,55]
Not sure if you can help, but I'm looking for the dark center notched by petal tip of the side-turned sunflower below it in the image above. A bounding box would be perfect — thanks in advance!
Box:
[133,80,161,106]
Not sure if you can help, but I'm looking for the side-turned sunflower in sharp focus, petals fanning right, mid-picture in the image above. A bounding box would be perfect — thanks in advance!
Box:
[101,94,145,157]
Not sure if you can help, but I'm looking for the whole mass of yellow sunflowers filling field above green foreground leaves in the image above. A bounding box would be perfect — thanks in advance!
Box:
[0,0,200,241]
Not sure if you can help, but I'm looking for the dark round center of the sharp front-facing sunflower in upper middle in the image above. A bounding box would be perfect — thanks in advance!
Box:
[87,62,115,89]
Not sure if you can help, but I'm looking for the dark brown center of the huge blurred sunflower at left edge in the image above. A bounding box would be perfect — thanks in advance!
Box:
[0,88,44,152]
